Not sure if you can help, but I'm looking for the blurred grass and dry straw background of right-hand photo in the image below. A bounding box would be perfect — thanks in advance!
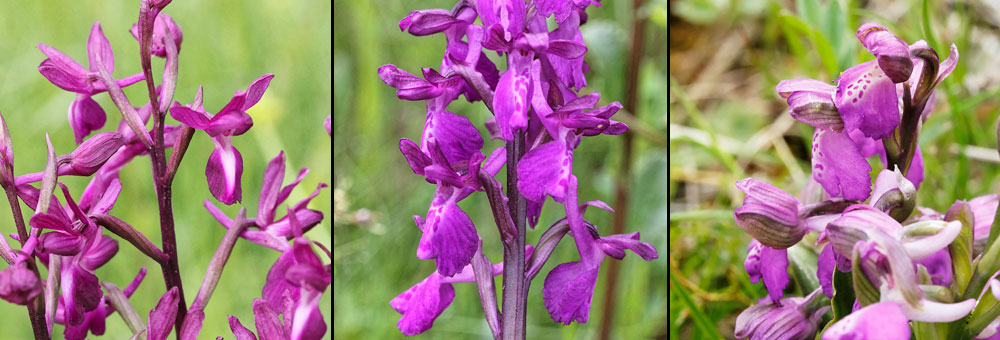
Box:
[669,0,1000,339]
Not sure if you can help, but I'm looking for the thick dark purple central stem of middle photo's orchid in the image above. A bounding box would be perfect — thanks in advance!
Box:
[501,131,528,340]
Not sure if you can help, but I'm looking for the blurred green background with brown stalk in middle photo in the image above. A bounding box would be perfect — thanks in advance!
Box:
[333,0,668,339]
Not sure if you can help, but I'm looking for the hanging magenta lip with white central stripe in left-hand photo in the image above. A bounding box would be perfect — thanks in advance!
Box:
[205,141,243,205]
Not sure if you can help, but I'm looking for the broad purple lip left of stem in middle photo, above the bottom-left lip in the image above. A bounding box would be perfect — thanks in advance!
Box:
[430,202,479,277]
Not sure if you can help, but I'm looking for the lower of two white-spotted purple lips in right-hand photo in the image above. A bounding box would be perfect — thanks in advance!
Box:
[812,129,871,201]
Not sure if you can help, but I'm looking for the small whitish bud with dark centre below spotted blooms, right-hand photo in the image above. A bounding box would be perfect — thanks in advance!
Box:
[871,167,917,222]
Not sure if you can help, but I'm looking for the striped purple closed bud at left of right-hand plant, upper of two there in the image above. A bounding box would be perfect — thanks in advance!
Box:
[733,178,807,249]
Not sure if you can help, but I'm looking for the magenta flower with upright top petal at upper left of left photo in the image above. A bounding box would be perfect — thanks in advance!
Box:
[38,22,145,144]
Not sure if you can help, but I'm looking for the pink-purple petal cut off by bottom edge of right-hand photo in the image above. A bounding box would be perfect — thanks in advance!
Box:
[823,301,910,340]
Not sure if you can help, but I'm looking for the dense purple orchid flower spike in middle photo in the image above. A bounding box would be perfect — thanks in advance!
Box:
[378,0,657,336]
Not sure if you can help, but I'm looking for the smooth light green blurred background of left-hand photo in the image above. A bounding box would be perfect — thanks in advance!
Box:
[0,0,333,339]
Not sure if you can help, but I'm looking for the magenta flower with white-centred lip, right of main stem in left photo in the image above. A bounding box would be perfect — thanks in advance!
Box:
[170,73,274,205]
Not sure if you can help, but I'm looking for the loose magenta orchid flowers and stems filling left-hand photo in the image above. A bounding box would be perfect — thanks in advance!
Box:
[0,0,332,339]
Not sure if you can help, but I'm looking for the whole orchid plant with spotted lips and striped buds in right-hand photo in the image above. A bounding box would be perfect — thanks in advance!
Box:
[734,24,1000,339]
